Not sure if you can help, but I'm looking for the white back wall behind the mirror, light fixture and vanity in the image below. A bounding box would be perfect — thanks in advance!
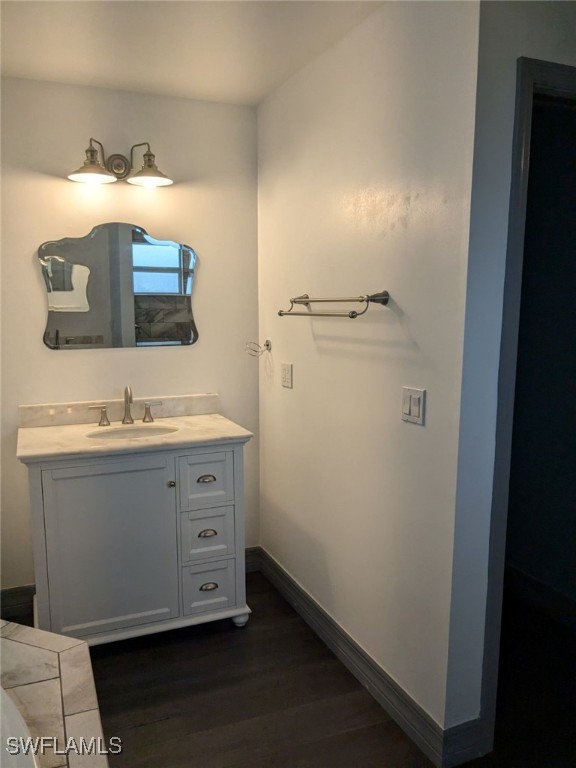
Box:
[2,79,258,588]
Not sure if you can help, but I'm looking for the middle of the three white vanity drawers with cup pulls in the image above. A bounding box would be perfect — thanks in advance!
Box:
[180,506,234,563]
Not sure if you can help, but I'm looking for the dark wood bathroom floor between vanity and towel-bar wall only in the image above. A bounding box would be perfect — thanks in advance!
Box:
[91,573,432,768]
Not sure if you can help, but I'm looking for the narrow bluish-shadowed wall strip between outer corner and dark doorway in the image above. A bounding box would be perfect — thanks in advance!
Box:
[447,2,576,722]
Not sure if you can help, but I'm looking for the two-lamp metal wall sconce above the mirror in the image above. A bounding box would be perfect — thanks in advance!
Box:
[68,139,174,187]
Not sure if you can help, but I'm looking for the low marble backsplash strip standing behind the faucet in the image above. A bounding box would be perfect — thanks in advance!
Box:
[18,393,220,427]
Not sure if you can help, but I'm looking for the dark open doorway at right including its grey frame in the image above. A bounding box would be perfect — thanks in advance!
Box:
[483,59,576,768]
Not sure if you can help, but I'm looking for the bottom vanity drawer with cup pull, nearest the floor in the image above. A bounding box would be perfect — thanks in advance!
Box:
[182,558,236,616]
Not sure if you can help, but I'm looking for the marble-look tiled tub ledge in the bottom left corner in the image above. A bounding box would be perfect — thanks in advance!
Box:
[0,621,108,768]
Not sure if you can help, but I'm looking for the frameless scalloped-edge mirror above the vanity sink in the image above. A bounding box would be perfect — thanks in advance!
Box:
[38,222,198,349]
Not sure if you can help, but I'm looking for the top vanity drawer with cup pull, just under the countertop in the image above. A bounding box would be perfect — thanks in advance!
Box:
[180,452,234,511]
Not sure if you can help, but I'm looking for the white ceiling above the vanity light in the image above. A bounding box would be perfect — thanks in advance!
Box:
[0,0,381,104]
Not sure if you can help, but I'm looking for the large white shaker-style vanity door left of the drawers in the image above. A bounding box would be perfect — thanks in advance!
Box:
[42,454,179,637]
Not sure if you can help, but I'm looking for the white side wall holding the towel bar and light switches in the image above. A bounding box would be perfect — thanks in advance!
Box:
[258,2,480,725]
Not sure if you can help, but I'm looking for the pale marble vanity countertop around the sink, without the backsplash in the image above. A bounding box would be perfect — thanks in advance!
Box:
[16,413,252,464]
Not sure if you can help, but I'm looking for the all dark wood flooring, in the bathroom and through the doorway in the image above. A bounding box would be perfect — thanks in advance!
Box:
[91,573,576,768]
